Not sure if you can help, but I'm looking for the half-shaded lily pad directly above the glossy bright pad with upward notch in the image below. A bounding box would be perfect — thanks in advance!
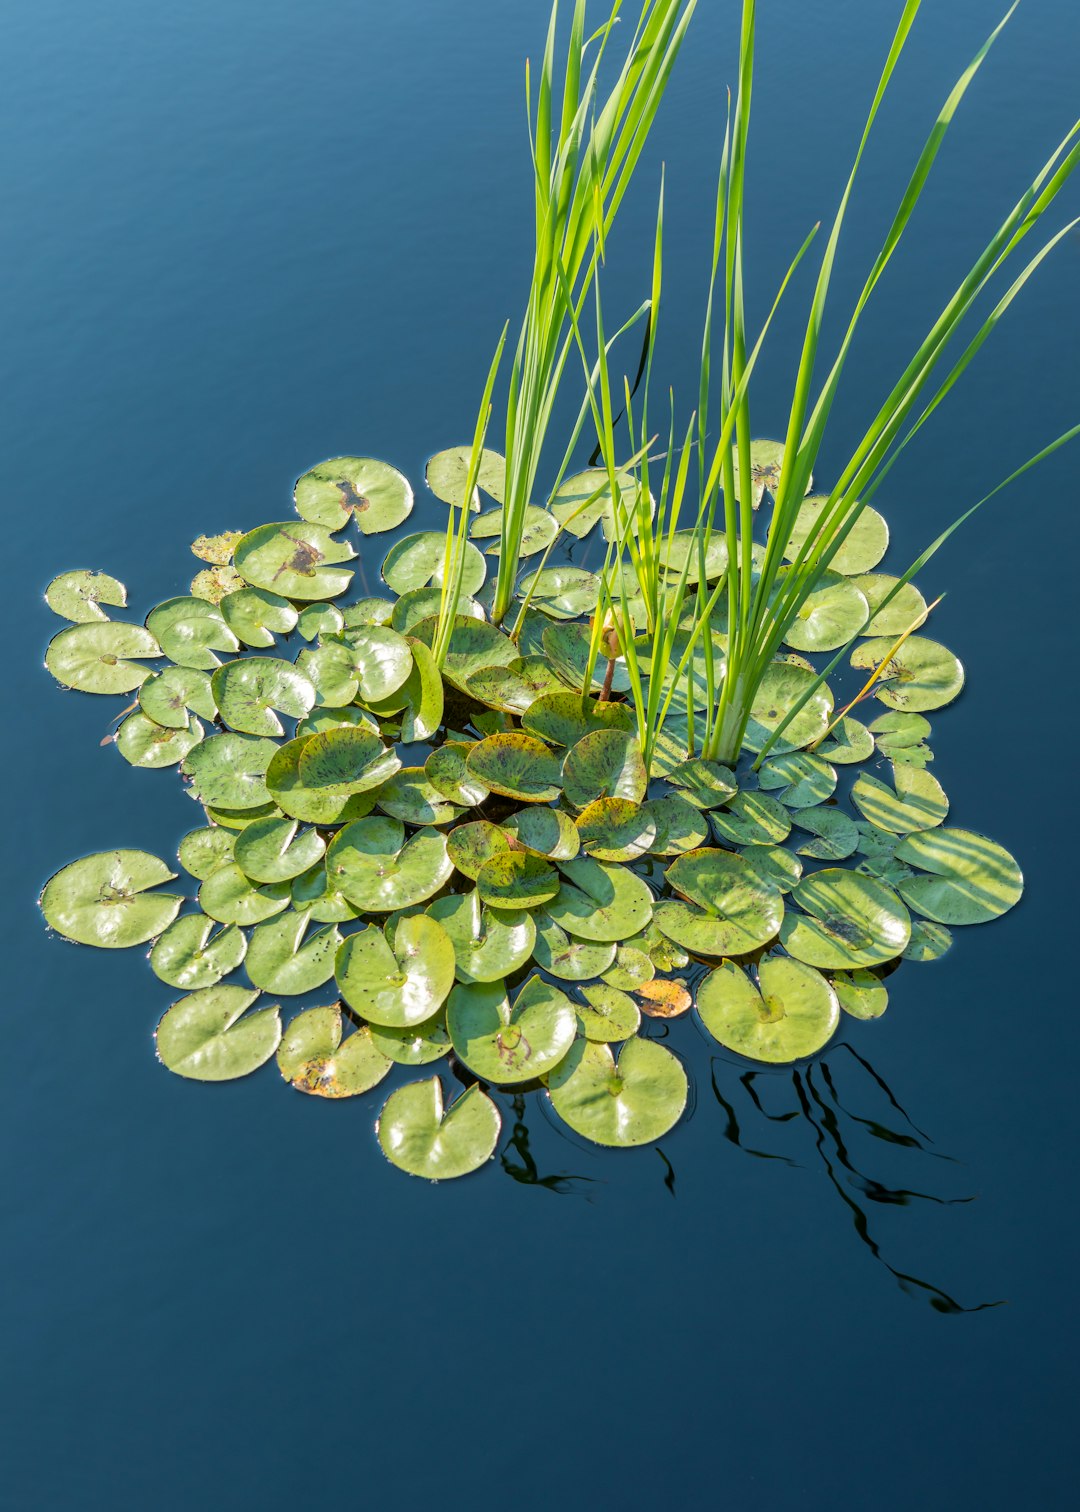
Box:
[327,818,454,907]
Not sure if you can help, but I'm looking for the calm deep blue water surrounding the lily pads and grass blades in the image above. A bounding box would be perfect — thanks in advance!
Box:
[0,0,1080,1512]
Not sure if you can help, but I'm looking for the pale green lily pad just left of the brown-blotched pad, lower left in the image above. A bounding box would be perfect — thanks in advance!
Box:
[156,987,281,1081]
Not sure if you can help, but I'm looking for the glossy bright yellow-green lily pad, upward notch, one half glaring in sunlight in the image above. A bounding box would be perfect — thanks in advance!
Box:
[337,913,455,1028]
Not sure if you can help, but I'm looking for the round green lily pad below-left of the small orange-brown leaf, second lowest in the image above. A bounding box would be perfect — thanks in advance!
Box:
[548,1039,690,1148]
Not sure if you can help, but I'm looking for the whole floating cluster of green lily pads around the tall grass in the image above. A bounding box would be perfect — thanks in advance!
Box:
[41,442,1023,1179]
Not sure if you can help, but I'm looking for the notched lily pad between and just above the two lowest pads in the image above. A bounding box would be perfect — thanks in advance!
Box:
[446,975,578,1086]
